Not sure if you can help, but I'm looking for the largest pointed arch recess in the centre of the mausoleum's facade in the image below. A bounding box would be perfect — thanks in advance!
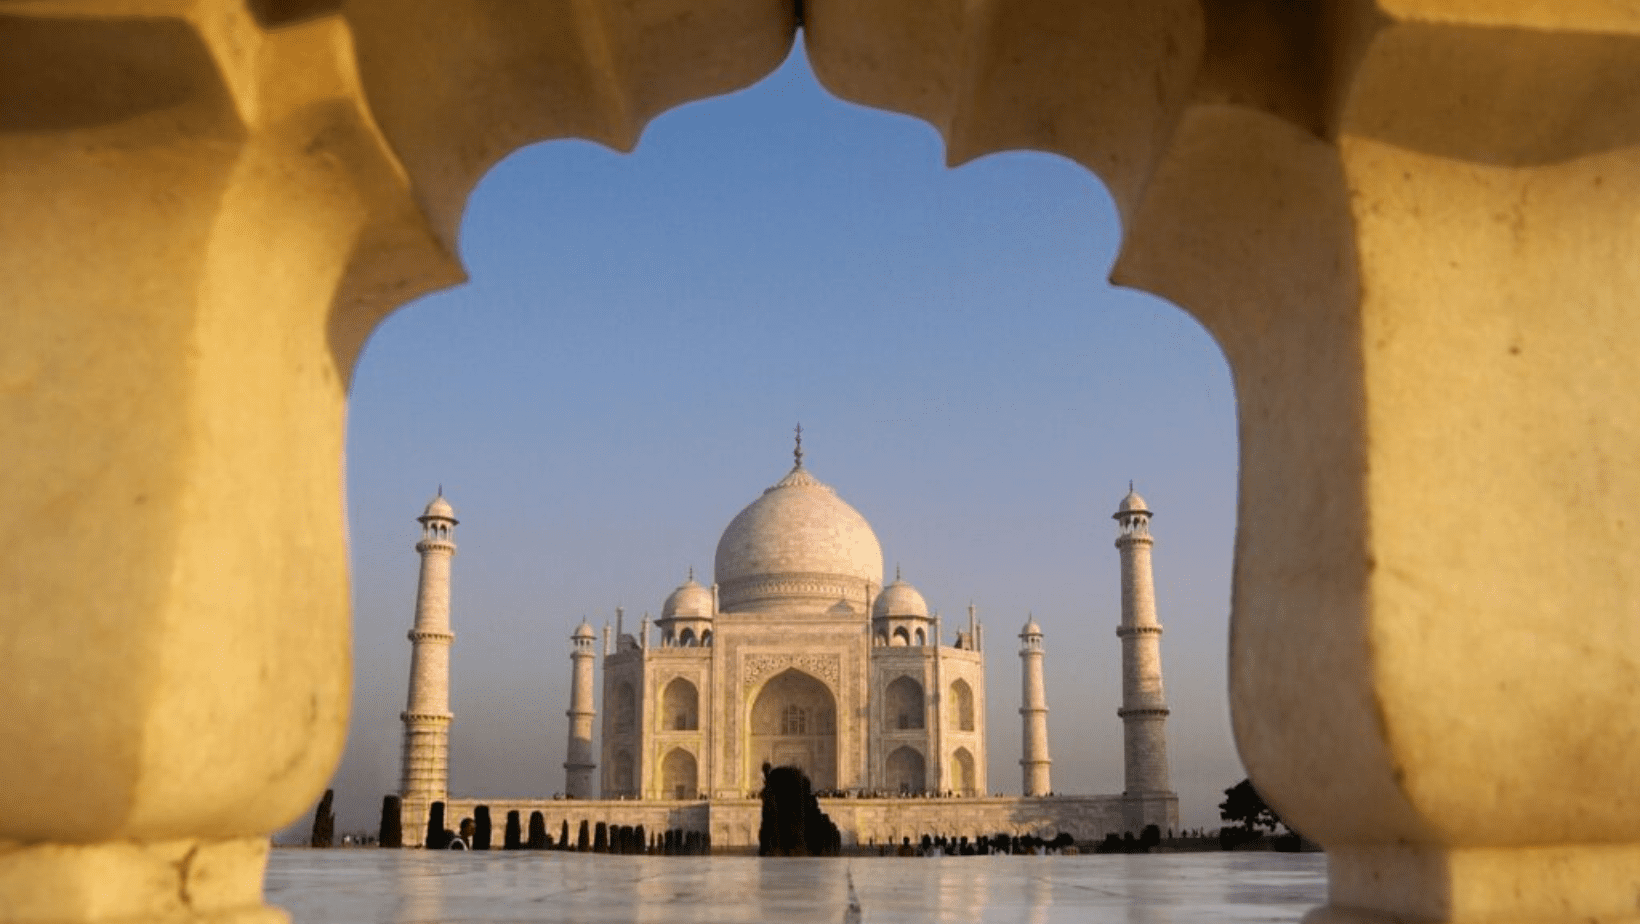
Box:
[746,668,836,789]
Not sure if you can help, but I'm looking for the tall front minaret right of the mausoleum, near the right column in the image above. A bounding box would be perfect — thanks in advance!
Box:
[1112,484,1173,796]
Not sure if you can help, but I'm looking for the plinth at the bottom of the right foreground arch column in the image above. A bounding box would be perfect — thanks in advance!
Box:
[1304,844,1640,924]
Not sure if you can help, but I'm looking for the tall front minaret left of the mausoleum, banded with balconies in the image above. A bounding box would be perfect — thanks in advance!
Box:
[399,487,456,844]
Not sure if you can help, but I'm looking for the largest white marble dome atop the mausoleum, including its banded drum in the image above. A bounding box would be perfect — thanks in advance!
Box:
[713,463,882,611]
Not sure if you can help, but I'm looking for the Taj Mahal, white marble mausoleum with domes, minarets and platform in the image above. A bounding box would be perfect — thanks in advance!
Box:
[400,428,1179,849]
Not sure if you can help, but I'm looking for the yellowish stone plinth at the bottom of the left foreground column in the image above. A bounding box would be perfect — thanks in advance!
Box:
[0,837,290,924]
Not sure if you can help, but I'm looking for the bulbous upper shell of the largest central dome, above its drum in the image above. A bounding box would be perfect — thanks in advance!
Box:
[713,464,882,609]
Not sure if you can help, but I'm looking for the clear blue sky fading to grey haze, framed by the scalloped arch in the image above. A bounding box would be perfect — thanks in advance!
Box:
[308,49,1243,832]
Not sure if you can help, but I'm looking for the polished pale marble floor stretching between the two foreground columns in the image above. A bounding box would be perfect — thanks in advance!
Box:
[267,850,1327,924]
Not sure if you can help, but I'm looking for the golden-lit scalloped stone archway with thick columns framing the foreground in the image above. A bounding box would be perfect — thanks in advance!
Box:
[9,0,1640,921]
